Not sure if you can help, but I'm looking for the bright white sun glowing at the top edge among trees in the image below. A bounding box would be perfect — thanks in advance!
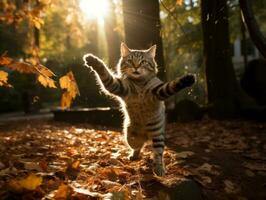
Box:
[79,0,108,23]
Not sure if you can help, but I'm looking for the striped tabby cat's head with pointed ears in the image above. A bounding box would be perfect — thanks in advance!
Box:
[120,43,157,80]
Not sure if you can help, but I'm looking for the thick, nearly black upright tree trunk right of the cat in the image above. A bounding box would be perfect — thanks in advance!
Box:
[201,0,238,117]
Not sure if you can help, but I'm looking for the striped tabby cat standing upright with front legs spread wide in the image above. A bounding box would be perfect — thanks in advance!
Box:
[83,43,195,176]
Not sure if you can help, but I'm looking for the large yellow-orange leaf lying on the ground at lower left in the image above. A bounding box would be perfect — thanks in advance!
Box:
[9,174,42,191]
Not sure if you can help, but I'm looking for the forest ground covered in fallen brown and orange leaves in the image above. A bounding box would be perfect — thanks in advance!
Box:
[0,119,266,200]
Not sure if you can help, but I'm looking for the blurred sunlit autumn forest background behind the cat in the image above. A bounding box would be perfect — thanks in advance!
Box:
[0,0,266,119]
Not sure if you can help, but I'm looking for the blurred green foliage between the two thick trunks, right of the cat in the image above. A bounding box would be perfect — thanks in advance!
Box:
[161,0,205,103]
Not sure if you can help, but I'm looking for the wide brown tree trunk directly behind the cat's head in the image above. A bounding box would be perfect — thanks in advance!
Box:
[123,0,165,79]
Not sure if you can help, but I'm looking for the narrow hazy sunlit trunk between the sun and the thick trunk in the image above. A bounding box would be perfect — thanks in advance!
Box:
[104,1,120,69]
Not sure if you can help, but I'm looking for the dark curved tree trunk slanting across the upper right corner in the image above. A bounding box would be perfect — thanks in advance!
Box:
[239,0,266,58]
